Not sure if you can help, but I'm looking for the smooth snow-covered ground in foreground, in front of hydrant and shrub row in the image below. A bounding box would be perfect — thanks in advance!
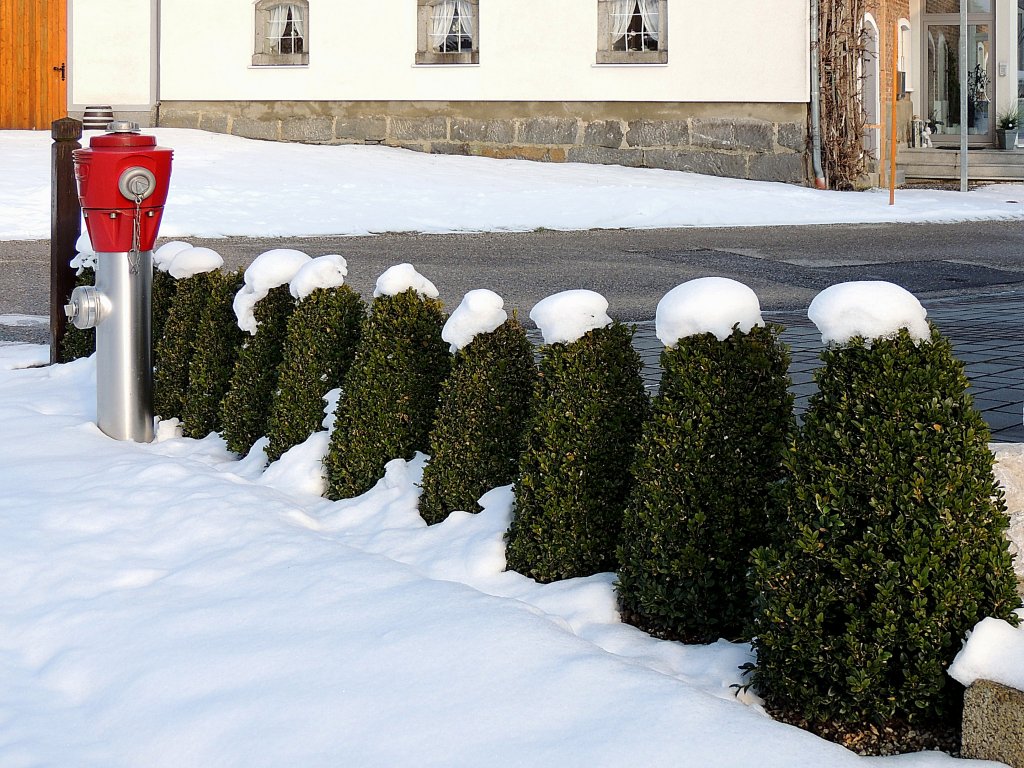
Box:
[0,345,1015,768]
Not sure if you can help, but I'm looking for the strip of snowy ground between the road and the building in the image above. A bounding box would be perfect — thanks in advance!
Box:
[0,128,1024,240]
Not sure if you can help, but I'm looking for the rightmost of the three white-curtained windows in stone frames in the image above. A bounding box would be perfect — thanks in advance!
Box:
[597,0,669,63]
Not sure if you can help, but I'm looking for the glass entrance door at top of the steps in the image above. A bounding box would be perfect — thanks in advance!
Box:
[923,0,995,145]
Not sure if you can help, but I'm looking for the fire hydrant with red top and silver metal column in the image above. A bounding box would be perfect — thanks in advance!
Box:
[65,122,173,442]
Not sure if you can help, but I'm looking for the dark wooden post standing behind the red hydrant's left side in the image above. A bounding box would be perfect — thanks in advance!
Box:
[50,118,82,362]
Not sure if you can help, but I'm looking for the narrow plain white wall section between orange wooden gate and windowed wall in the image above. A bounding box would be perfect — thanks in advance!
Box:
[68,0,157,111]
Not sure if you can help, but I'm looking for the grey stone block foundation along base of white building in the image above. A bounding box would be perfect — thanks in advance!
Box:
[158,101,808,183]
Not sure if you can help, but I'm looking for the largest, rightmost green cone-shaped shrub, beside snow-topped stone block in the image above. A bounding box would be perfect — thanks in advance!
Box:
[752,328,1020,723]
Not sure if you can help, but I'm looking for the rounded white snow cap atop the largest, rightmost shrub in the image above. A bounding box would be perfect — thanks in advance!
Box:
[807,281,932,344]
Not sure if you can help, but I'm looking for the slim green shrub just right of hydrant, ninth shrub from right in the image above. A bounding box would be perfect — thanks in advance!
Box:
[153,272,217,419]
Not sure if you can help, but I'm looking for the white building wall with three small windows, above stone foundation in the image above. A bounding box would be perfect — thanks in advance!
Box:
[157,0,809,103]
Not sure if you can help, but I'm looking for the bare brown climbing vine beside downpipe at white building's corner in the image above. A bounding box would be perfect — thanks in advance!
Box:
[818,0,865,189]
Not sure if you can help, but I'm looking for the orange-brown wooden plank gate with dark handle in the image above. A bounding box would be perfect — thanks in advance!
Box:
[0,0,68,129]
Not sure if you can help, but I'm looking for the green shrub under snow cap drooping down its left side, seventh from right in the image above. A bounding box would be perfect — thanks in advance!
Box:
[220,284,295,454]
